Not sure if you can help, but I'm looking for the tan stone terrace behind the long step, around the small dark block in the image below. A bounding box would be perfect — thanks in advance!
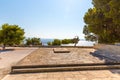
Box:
[17,48,104,65]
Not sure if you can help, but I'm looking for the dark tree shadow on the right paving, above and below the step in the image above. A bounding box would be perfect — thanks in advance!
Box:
[90,50,120,74]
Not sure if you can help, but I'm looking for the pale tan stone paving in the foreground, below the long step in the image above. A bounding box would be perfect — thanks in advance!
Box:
[2,70,120,80]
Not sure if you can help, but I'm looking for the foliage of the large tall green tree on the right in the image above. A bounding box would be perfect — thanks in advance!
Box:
[83,0,120,43]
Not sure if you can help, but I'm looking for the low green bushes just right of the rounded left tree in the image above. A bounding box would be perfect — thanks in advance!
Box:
[26,37,41,45]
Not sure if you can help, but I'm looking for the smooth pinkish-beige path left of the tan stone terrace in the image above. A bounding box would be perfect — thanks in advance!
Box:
[0,47,37,79]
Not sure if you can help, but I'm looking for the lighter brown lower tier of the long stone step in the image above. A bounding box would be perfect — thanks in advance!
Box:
[11,64,120,74]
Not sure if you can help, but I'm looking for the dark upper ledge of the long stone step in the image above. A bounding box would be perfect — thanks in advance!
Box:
[11,62,120,69]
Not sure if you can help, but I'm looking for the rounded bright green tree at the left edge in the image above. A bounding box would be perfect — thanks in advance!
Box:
[0,24,25,49]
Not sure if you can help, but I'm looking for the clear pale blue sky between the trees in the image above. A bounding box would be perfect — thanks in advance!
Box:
[0,0,93,39]
